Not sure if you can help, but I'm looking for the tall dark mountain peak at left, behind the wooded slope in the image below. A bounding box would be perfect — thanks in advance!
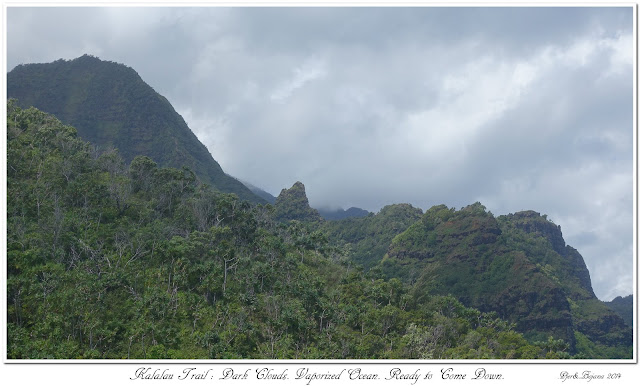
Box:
[7,55,266,203]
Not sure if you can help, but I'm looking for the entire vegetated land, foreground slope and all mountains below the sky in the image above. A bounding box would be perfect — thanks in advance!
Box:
[7,56,633,358]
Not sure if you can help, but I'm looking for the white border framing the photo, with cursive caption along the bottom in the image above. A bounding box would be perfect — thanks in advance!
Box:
[0,0,640,385]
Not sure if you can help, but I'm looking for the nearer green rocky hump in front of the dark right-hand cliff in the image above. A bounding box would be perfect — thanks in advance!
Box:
[383,203,574,345]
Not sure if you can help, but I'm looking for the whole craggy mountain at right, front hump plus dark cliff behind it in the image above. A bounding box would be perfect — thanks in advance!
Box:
[380,203,632,356]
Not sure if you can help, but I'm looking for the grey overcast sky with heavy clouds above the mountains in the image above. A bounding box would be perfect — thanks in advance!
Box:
[6,7,634,300]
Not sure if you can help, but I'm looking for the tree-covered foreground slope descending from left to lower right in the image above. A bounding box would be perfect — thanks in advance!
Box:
[7,101,568,358]
